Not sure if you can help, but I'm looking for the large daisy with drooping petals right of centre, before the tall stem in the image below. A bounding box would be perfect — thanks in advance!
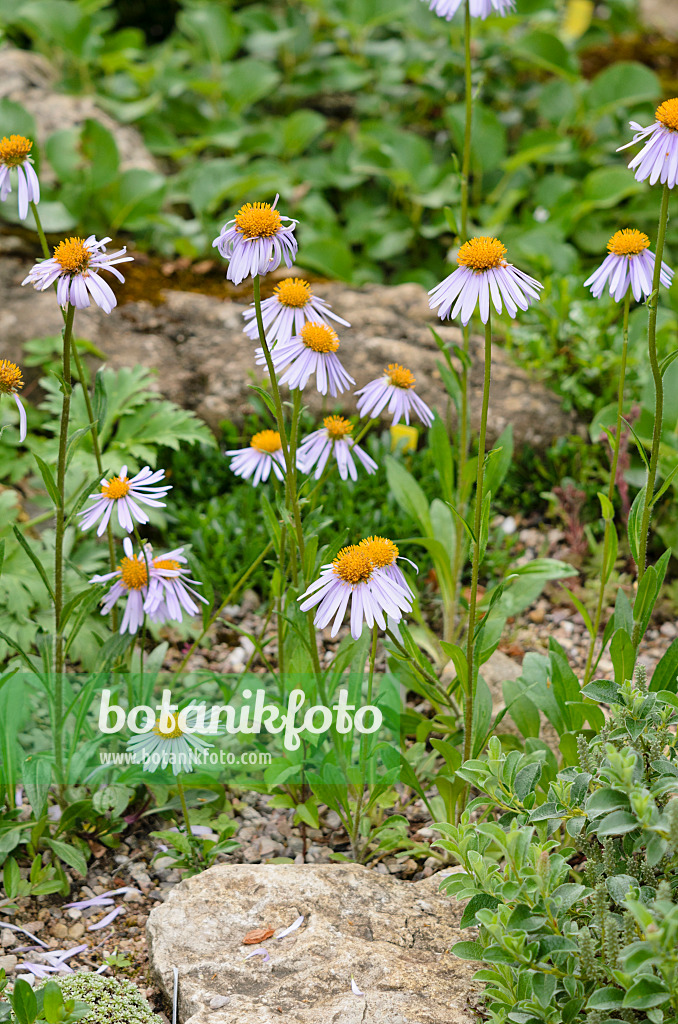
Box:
[428,238,544,327]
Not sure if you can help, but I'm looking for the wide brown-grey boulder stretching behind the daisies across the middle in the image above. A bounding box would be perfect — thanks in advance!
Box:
[0,249,578,447]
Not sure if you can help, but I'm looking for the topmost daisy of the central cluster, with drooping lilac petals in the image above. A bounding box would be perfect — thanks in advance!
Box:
[212,196,297,285]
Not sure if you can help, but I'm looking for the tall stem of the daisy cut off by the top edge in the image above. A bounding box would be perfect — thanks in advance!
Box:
[450,0,473,640]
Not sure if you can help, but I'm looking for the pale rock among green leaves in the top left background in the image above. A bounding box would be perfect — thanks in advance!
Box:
[0,45,158,175]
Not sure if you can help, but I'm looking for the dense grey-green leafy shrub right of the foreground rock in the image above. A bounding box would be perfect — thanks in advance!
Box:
[437,670,678,1024]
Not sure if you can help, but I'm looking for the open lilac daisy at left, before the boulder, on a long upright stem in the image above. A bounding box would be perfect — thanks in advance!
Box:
[22,234,134,313]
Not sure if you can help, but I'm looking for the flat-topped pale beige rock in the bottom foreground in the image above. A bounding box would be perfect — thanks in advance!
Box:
[147,864,477,1024]
